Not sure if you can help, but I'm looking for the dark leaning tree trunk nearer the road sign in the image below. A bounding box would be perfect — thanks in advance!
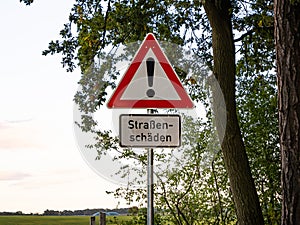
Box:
[204,0,264,225]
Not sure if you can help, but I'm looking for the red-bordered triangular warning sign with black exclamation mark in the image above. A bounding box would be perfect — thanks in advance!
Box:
[107,34,194,108]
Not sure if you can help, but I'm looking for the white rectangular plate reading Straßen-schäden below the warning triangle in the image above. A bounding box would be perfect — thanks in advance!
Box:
[120,114,181,148]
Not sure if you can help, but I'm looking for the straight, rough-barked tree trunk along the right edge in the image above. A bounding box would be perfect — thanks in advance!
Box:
[274,0,300,225]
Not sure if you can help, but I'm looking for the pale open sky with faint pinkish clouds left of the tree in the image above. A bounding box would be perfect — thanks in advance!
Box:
[0,0,126,213]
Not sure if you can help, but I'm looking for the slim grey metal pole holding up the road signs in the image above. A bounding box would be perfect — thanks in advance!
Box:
[147,109,154,225]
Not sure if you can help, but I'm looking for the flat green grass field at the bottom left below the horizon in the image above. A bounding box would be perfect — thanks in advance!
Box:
[0,216,132,225]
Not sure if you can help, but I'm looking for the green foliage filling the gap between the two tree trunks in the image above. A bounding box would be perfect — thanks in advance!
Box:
[237,2,281,224]
